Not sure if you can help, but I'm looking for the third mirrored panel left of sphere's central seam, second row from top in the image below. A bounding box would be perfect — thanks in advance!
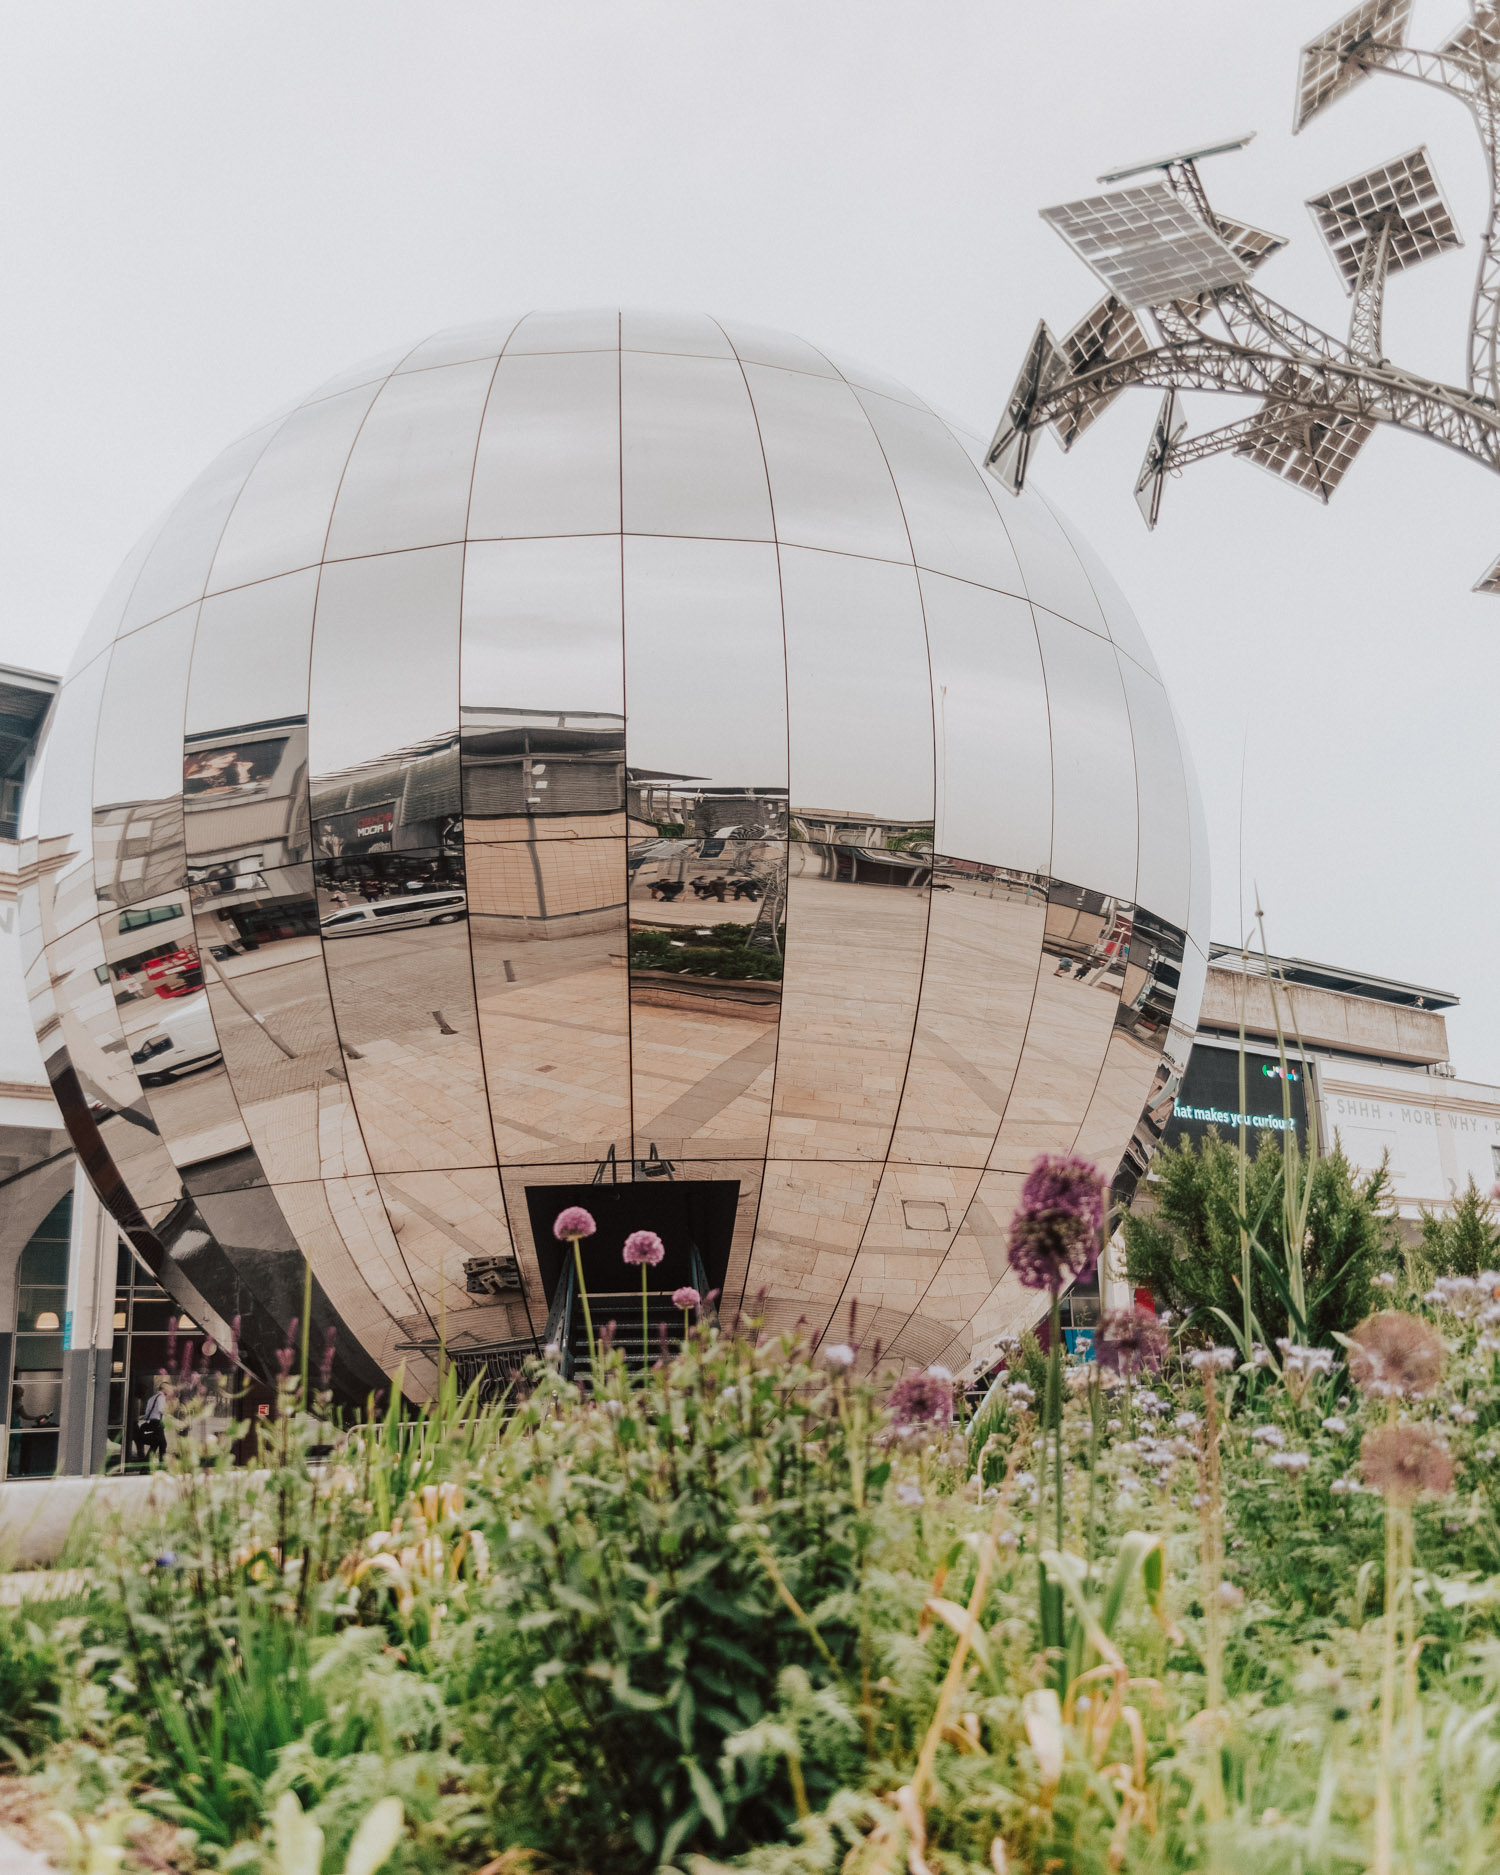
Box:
[208,381,381,585]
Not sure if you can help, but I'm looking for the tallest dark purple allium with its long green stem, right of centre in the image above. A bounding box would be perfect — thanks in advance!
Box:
[1009,1153,1104,1693]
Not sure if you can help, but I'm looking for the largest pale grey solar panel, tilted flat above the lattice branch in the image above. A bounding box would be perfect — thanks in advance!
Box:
[1043,182,1249,308]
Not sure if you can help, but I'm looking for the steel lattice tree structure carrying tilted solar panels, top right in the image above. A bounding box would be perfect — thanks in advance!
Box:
[986,0,1500,593]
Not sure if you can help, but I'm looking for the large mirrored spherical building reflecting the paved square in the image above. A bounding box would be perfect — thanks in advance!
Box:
[24,311,1208,1399]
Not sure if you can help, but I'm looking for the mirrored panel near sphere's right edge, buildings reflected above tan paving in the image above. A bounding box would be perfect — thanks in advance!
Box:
[990,879,1131,1172]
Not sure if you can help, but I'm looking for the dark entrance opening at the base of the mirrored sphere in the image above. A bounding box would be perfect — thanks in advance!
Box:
[527,1178,739,1373]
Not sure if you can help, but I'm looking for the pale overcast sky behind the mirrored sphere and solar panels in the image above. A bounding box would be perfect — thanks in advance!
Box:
[0,0,1500,1082]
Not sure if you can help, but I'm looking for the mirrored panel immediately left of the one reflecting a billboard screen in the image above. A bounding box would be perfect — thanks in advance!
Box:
[94,606,197,908]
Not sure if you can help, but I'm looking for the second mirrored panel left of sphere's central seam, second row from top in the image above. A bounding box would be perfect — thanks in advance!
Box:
[324,358,493,561]
